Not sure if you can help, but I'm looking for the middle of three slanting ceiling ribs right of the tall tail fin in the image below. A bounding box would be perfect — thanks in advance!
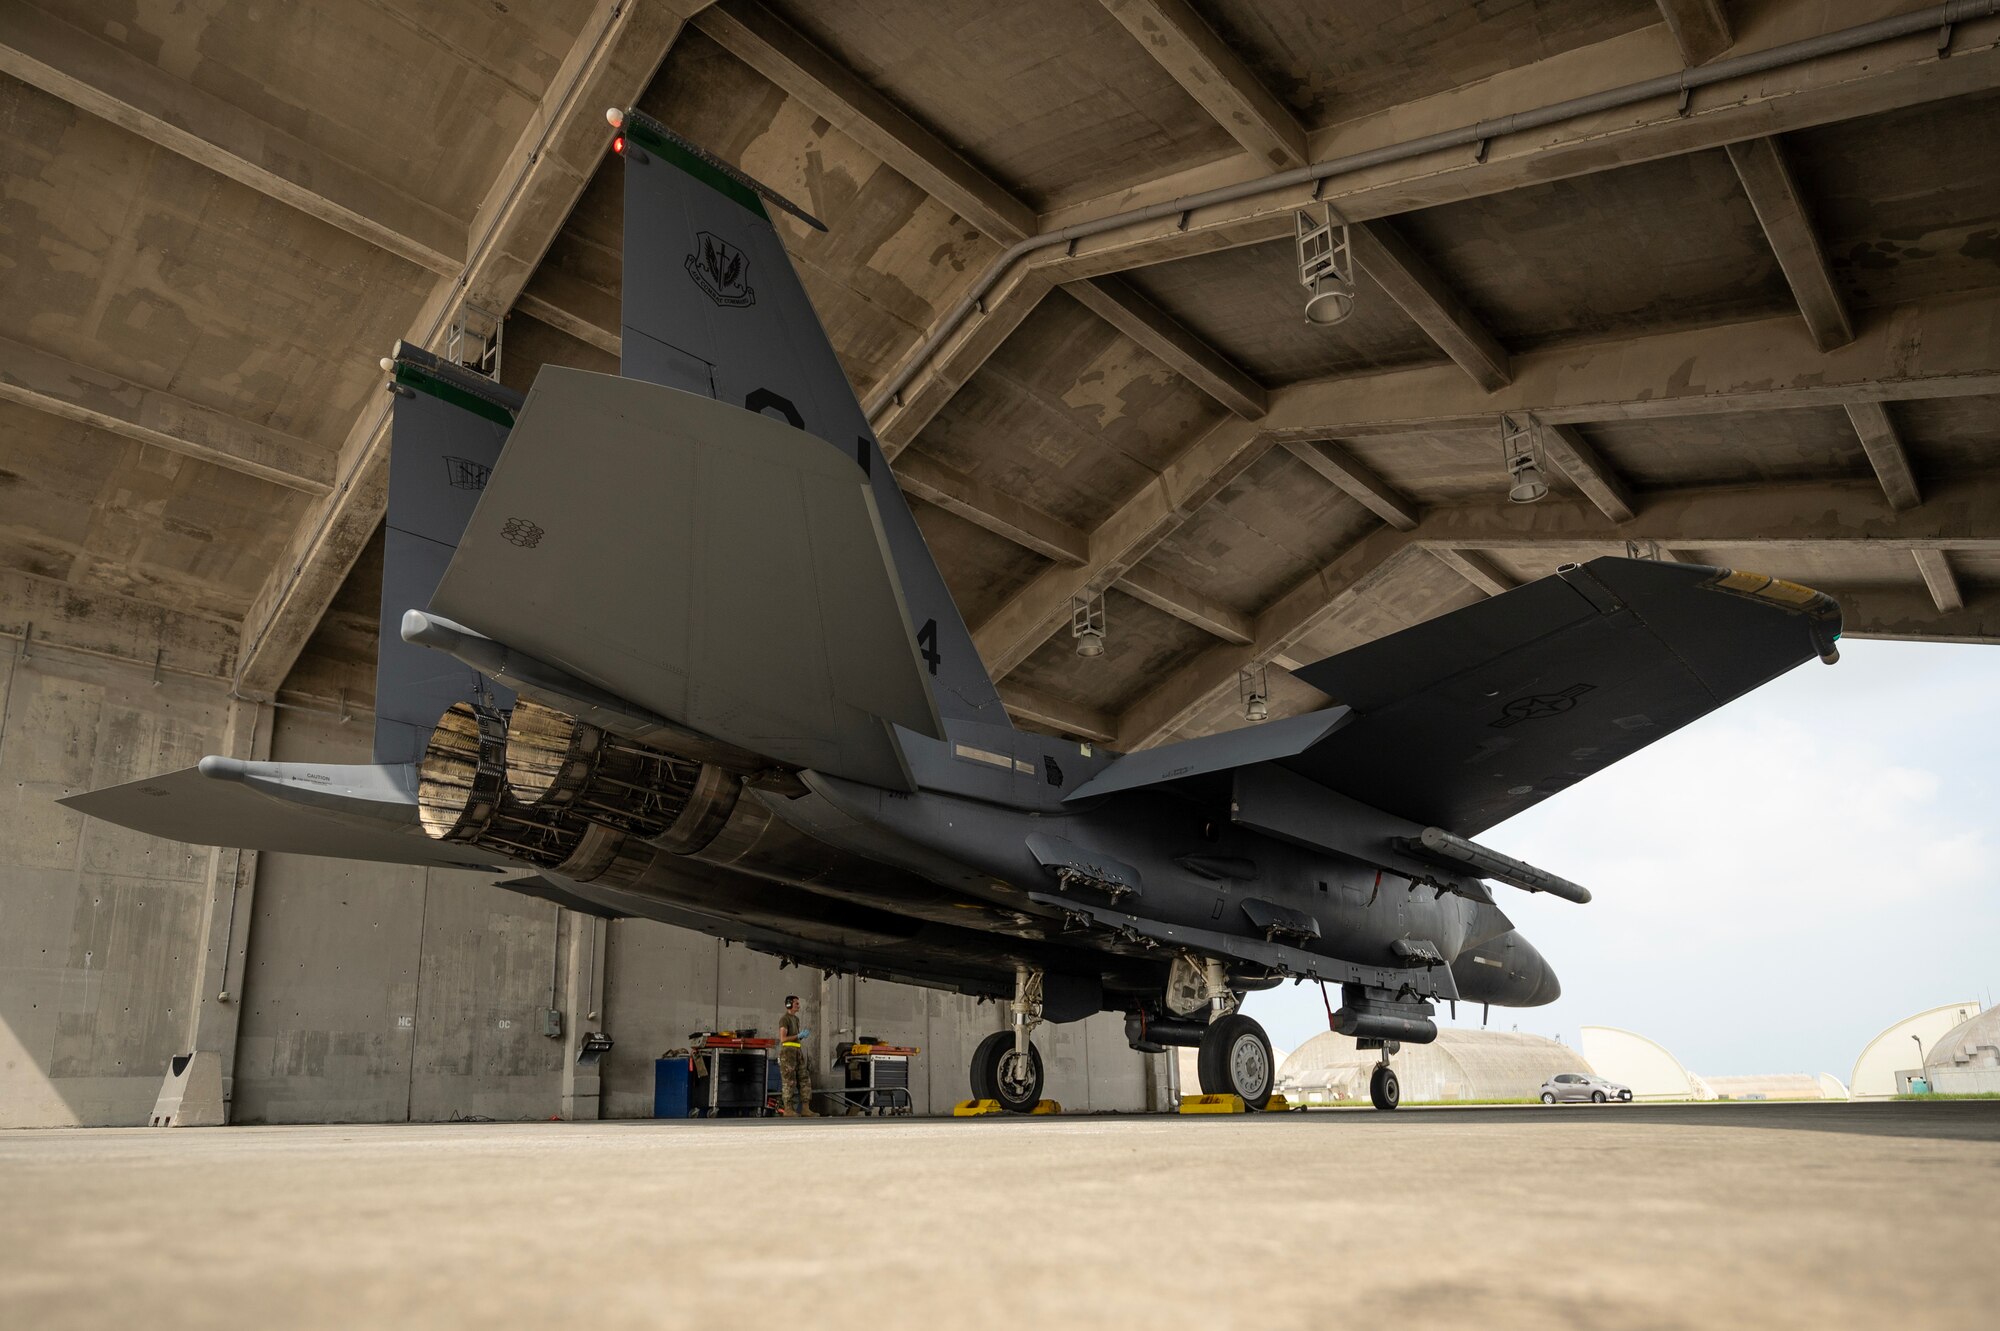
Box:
[972,420,1268,679]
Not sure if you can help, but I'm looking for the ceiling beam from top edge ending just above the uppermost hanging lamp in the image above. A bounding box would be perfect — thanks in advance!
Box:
[1102,0,1306,172]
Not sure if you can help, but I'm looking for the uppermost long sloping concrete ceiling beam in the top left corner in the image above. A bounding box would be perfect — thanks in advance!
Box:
[0,4,466,274]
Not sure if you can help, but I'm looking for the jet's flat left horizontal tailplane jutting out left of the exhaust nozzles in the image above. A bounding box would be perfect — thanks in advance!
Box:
[60,757,504,869]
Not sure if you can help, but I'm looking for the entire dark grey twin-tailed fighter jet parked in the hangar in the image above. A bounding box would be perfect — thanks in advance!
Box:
[66,112,1840,1111]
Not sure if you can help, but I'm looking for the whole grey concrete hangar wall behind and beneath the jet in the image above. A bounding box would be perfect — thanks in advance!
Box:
[0,640,1166,1127]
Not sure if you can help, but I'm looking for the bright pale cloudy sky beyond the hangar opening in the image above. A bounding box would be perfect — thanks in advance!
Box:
[1244,640,2000,1081]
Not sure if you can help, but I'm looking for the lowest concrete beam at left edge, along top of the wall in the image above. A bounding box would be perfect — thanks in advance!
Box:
[0,568,238,679]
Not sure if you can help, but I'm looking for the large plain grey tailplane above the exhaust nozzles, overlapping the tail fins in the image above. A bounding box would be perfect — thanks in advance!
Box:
[430,366,944,789]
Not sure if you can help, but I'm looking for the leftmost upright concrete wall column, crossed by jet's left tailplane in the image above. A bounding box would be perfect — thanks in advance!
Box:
[174,699,274,1127]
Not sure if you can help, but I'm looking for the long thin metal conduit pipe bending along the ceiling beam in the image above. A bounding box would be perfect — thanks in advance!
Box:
[868,0,2000,420]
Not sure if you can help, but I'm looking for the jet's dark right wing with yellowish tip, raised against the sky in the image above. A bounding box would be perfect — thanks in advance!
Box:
[1280,558,1840,835]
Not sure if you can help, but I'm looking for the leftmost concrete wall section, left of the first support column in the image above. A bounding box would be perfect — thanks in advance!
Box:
[0,638,232,1127]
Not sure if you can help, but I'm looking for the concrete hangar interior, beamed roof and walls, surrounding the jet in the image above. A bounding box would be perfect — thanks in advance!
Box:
[0,0,2000,1121]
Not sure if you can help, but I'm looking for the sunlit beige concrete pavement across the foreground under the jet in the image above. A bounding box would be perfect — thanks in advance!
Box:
[0,1101,2000,1331]
